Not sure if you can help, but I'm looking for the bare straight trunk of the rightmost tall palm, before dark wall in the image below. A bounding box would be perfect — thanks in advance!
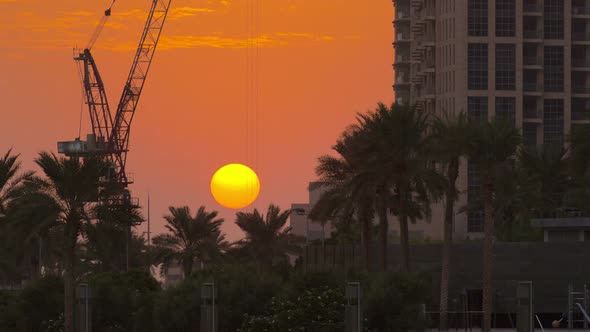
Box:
[482,171,494,332]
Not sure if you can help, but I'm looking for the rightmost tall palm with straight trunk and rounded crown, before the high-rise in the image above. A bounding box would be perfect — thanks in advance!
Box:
[468,119,521,332]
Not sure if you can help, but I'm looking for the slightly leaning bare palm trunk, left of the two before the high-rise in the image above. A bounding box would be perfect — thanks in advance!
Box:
[439,159,459,331]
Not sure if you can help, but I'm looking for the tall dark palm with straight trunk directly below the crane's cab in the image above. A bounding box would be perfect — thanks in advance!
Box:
[11,152,108,332]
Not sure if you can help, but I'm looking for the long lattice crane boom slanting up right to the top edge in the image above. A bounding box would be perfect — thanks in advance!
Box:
[110,0,171,185]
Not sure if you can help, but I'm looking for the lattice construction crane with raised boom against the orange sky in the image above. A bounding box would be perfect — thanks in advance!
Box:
[57,0,171,199]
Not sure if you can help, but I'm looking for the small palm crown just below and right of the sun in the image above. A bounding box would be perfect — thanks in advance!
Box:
[236,204,294,267]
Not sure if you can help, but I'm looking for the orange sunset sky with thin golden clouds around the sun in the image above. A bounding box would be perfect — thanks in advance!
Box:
[0,0,394,240]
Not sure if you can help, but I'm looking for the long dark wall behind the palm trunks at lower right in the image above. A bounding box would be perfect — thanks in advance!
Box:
[303,242,590,313]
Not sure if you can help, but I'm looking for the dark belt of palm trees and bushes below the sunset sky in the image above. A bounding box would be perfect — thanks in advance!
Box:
[0,104,590,332]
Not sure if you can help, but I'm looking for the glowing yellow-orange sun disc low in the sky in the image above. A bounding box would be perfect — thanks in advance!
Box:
[211,164,260,209]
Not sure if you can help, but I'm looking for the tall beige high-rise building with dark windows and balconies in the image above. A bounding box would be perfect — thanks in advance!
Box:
[393,0,590,237]
